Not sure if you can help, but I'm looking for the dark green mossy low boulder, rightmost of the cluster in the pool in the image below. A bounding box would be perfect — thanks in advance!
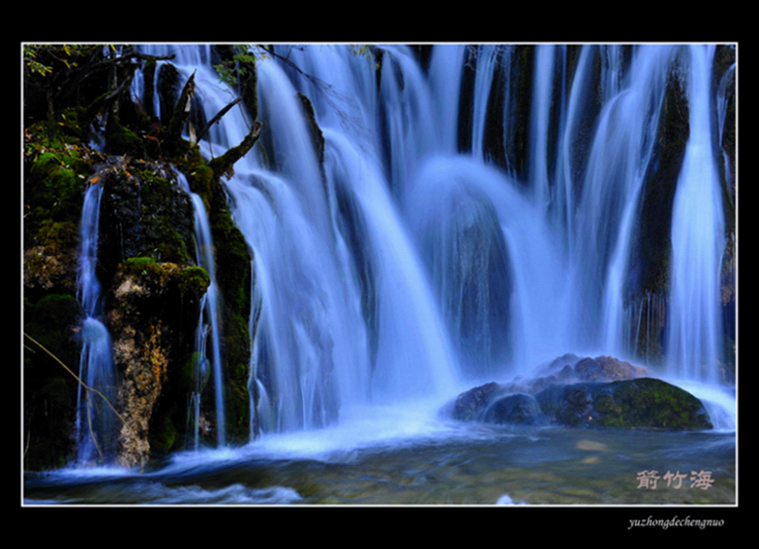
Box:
[535,378,712,430]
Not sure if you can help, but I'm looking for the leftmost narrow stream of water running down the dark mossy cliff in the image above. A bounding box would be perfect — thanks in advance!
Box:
[75,184,116,465]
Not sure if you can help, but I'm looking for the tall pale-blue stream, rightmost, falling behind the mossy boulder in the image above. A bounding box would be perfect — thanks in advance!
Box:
[668,46,725,383]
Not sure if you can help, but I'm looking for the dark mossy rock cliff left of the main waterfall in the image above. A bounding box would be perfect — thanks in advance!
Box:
[23,45,251,469]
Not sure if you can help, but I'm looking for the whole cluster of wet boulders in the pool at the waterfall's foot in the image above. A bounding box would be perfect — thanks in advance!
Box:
[448,354,712,430]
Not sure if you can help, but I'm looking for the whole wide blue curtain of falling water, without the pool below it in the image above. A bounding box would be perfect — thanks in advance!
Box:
[127,45,724,446]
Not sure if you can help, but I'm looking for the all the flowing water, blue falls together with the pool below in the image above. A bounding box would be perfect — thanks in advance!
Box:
[25,44,737,506]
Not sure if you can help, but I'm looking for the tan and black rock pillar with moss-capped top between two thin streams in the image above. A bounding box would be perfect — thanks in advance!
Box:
[106,257,208,467]
